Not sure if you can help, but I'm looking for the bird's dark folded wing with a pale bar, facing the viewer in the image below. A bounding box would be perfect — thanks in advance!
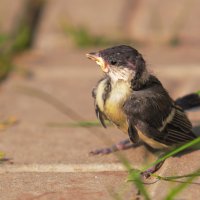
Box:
[124,86,195,146]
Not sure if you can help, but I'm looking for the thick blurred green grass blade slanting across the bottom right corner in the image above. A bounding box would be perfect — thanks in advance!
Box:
[165,169,200,200]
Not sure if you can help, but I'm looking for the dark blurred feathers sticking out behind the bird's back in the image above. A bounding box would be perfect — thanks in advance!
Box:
[175,91,200,110]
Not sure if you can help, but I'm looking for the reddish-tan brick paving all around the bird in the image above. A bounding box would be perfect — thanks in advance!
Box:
[0,0,200,200]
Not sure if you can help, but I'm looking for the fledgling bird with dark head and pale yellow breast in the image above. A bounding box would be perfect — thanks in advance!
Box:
[86,45,197,177]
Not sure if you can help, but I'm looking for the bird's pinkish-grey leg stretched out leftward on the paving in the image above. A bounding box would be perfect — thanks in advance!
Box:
[90,139,135,155]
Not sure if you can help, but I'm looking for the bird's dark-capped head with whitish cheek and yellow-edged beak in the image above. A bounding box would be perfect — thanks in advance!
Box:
[86,45,146,80]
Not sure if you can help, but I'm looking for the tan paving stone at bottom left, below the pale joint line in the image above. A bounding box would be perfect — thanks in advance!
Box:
[0,172,136,200]
